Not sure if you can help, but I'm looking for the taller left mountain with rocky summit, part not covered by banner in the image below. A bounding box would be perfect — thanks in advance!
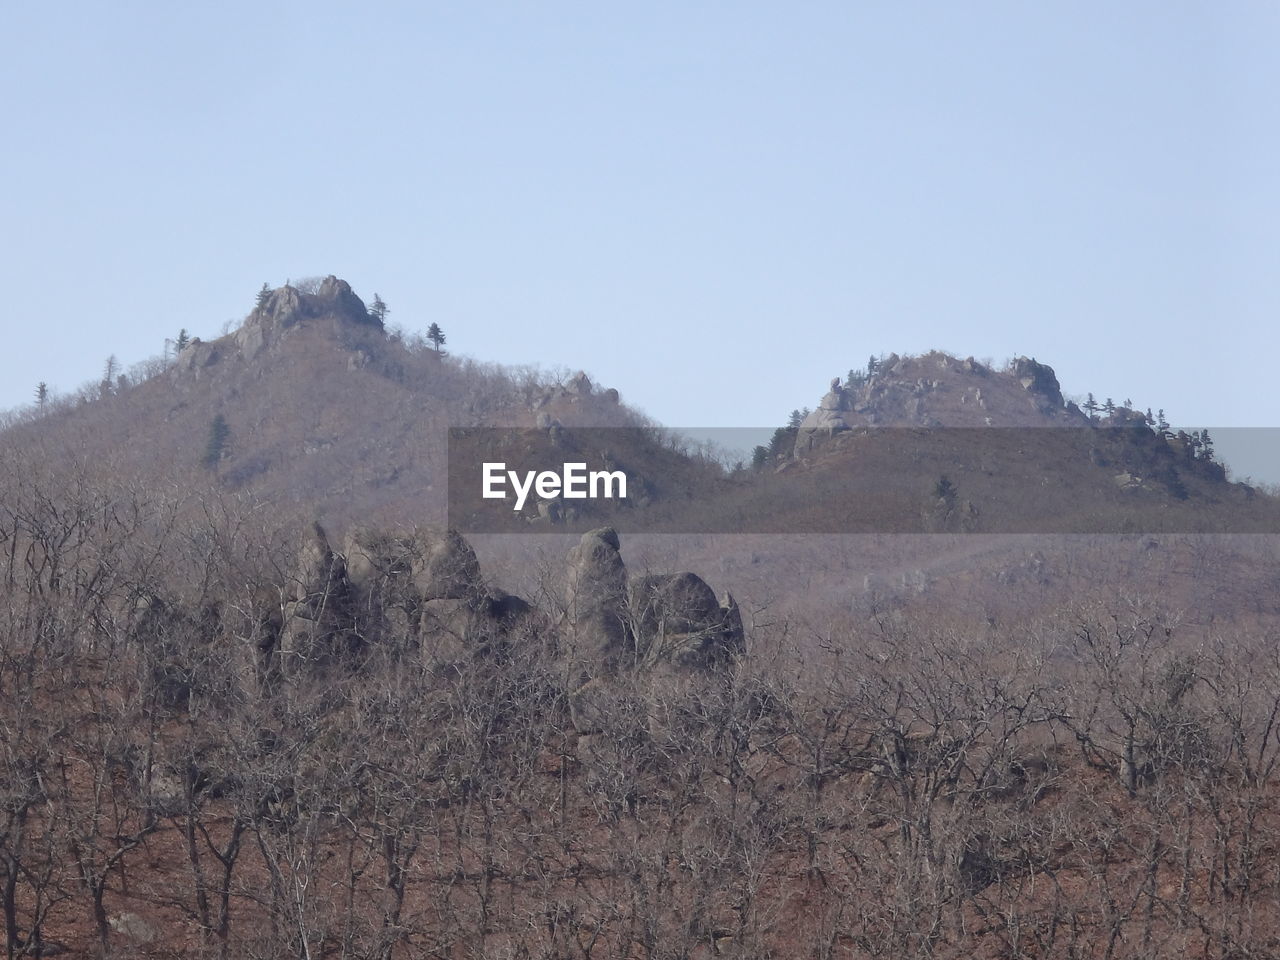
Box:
[4,276,675,526]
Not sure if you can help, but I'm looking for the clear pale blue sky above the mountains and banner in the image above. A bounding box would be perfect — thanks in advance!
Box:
[0,0,1280,426]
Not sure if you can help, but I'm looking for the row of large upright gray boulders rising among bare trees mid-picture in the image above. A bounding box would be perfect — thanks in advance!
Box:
[259,524,744,684]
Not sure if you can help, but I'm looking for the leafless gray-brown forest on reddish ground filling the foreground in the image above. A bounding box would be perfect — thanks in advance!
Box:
[0,448,1280,960]
